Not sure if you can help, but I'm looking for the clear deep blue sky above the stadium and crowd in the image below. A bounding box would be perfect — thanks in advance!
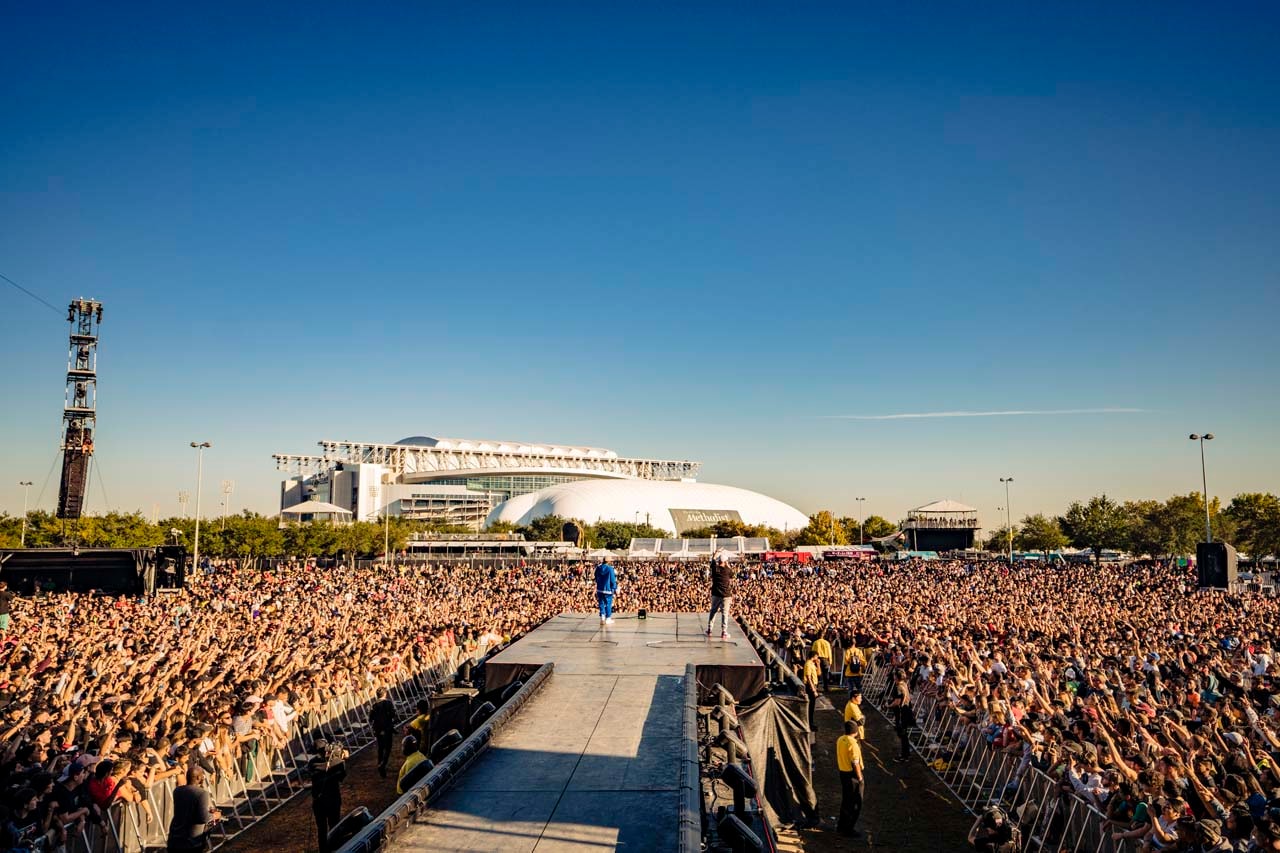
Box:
[0,3,1280,526]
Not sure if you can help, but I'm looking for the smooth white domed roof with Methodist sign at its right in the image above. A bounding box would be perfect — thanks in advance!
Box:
[485,479,809,532]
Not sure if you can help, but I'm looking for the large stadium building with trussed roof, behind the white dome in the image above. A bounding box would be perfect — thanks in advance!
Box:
[274,435,701,530]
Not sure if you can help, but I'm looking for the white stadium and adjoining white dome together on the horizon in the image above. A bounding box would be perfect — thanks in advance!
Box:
[274,435,806,533]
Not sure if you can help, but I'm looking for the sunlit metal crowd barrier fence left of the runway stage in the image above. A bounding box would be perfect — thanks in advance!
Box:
[58,637,486,853]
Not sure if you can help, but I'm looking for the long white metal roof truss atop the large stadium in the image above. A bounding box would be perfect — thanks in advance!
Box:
[274,441,703,480]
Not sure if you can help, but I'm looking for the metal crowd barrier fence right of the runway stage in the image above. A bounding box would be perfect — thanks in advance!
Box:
[863,661,1139,853]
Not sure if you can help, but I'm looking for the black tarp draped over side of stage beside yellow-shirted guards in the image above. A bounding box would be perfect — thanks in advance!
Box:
[737,694,818,826]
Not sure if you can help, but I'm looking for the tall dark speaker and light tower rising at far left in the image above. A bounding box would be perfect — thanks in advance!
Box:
[58,298,102,519]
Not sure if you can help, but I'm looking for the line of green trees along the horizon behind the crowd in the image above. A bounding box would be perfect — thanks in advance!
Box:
[0,492,1280,558]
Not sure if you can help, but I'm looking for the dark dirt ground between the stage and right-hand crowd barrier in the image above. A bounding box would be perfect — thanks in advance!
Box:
[800,689,973,853]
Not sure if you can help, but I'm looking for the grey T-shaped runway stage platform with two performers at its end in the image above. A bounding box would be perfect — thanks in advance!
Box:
[388,613,764,853]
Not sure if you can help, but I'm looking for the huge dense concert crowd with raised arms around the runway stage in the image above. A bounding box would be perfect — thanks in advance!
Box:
[0,561,1280,852]
